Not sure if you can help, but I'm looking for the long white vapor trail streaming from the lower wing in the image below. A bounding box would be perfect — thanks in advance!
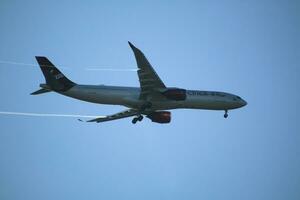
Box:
[0,111,104,118]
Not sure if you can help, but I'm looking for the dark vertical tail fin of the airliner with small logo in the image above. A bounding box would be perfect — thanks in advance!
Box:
[35,56,76,92]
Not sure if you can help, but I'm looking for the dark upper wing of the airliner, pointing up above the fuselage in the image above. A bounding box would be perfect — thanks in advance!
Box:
[128,42,166,99]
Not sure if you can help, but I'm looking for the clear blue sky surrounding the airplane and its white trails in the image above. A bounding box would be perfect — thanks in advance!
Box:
[0,0,300,200]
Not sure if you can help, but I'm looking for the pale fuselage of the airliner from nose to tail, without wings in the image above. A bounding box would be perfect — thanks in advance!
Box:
[59,85,247,111]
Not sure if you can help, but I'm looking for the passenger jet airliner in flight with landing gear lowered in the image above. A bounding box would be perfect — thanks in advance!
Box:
[31,42,247,124]
